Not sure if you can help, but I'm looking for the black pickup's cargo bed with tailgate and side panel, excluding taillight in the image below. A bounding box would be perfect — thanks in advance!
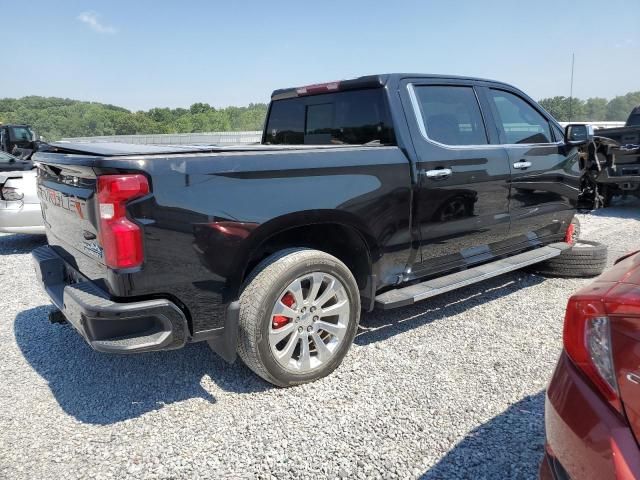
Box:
[34,142,411,335]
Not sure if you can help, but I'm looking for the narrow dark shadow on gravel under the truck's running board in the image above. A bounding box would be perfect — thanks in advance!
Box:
[354,271,546,345]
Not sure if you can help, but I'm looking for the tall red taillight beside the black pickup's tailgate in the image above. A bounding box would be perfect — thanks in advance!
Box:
[97,174,149,268]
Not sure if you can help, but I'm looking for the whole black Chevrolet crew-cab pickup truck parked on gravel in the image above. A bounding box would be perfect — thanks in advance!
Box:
[33,74,590,386]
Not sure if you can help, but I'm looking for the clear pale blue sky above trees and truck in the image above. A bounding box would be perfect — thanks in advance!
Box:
[0,0,640,110]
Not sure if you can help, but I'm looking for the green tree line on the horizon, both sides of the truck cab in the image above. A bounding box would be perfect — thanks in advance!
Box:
[0,91,640,141]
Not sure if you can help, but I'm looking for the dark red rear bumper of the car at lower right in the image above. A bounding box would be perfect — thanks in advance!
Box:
[540,353,640,480]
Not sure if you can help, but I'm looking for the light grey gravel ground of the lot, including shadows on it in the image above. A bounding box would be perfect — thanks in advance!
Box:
[0,197,640,479]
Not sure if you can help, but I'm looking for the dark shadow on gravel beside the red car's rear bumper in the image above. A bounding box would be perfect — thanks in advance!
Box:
[421,390,544,480]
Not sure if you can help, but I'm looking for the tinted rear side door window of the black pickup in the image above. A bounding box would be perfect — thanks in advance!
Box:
[414,85,488,145]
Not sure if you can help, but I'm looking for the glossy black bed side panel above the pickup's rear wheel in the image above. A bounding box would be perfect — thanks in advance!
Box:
[122,147,411,332]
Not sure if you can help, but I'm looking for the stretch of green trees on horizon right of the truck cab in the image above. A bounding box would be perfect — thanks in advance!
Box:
[540,91,640,122]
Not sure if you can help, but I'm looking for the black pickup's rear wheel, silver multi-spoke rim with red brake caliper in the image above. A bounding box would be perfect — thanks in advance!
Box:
[238,248,360,387]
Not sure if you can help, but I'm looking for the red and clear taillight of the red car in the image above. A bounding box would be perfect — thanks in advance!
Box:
[563,295,622,413]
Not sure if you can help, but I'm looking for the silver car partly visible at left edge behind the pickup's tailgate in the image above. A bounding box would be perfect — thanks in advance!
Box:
[0,152,44,234]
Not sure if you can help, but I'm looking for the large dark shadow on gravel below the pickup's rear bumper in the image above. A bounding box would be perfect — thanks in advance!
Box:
[15,306,271,425]
